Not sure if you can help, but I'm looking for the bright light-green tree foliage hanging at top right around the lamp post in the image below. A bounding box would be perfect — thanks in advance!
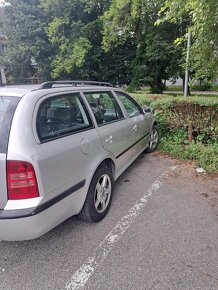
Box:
[161,0,218,80]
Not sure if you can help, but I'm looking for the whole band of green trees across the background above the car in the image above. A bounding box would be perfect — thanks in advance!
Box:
[0,0,218,86]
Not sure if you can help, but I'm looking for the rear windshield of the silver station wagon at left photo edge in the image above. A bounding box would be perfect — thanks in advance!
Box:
[0,96,20,153]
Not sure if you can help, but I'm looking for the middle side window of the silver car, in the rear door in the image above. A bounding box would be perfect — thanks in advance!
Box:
[84,92,124,125]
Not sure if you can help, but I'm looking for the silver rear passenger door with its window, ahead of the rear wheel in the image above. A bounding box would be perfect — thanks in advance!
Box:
[84,91,131,169]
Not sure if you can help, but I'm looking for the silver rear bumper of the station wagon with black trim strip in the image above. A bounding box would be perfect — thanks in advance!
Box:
[0,180,85,241]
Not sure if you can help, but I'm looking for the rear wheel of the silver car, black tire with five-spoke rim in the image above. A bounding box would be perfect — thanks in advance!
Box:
[78,165,114,223]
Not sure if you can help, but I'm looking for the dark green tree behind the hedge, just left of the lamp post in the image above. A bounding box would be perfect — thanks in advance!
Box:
[127,23,185,93]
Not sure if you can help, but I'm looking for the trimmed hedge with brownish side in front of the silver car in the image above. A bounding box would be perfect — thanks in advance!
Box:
[151,97,218,143]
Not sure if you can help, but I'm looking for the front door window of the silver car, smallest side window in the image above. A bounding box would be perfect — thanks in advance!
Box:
[116,92,142,118]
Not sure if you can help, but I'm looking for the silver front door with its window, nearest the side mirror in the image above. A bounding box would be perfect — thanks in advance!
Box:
[115,91,151,155]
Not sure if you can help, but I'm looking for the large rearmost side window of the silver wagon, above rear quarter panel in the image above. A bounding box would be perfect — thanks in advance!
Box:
[37,94,92,141]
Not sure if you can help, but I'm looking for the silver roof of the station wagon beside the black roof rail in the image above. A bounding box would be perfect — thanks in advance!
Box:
[0,84,117,97]
